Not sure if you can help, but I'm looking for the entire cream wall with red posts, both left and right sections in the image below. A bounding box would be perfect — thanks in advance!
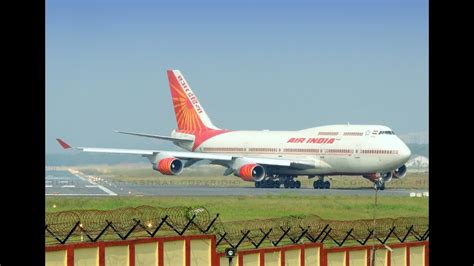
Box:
[46,235,429,266]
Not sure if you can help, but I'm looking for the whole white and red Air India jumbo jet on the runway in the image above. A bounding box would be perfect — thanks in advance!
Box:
[57,70,411,190]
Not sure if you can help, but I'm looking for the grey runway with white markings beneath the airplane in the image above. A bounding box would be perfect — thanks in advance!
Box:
[45,171,425,197]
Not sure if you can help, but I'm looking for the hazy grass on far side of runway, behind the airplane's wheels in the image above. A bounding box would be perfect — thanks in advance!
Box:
[75,164,429,189]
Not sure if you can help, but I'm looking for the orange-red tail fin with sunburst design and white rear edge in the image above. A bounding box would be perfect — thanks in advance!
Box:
[168,70,218,131]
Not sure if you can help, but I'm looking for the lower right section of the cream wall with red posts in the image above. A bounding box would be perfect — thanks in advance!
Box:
[219,241,429,266]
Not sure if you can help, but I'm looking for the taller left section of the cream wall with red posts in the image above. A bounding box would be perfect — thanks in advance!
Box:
[45,235,219,266]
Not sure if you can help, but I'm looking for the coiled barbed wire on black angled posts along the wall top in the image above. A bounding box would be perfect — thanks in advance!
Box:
[45,206,429,248]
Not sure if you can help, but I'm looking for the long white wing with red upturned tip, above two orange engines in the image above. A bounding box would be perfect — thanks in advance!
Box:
[56,139,319,169]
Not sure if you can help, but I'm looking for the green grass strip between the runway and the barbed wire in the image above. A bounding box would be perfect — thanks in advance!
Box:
[46,193,428,222]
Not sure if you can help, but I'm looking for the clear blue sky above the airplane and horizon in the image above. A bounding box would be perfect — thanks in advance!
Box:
[45,0,428,153]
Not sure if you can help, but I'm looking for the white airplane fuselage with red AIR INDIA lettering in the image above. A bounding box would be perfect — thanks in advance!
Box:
[172,125,411,175]
